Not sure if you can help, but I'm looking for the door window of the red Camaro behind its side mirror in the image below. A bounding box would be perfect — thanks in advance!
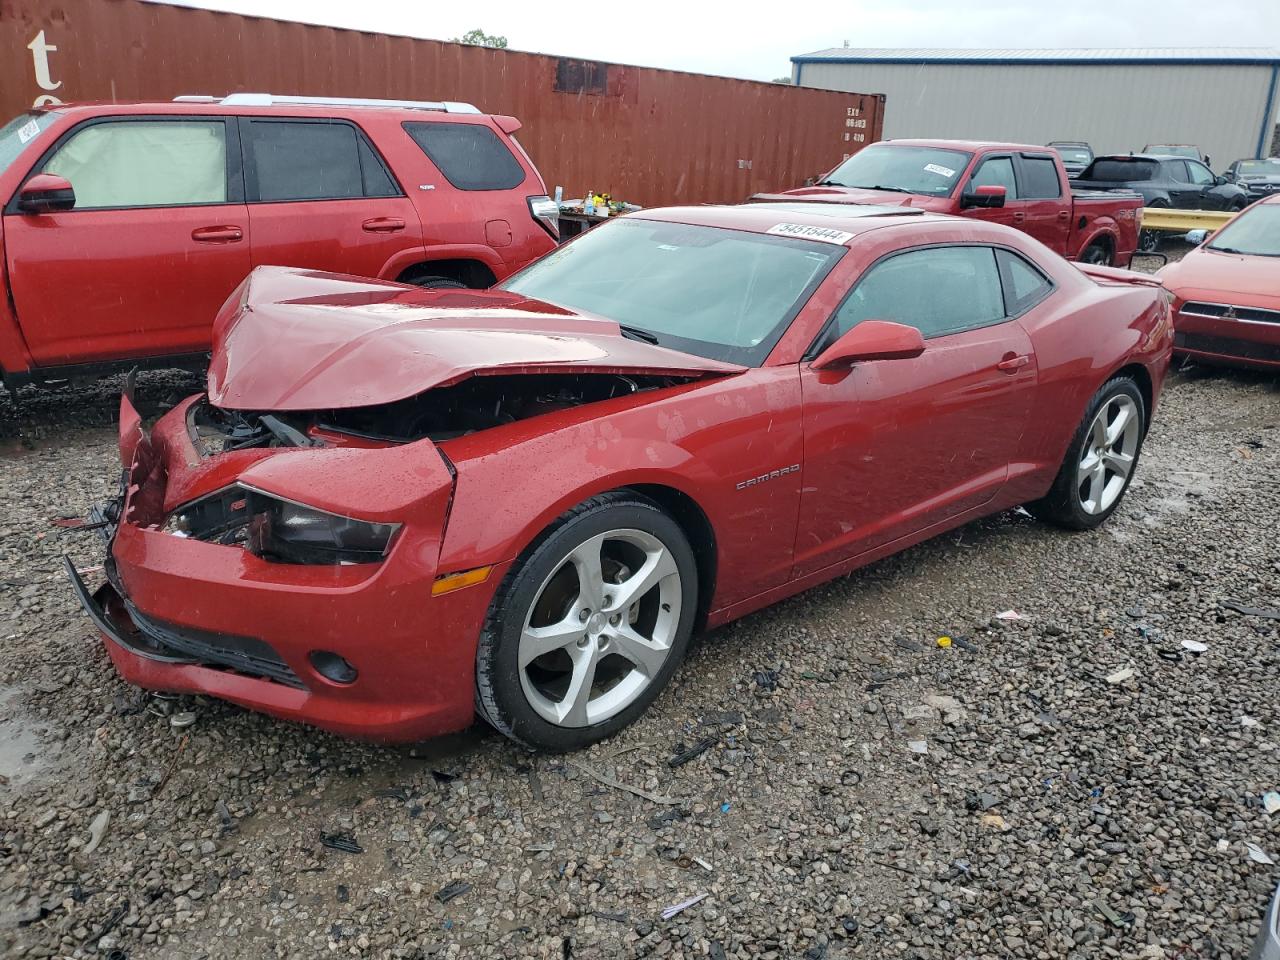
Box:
[835,247,1005,338]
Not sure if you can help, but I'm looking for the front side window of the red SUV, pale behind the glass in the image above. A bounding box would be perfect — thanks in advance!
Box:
[44,120,227,210]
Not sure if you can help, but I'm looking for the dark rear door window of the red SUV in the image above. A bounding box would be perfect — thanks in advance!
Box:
[248,120,365,201]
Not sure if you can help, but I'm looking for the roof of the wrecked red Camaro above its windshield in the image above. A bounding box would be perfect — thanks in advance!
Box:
[627,201,967,246]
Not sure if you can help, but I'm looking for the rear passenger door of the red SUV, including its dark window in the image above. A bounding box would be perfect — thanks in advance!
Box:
[241,118,432,279]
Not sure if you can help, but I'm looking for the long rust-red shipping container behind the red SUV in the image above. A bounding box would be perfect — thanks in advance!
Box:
[0,0,884,206]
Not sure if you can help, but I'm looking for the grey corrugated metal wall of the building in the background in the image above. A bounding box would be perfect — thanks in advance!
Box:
[791,63,1280,169]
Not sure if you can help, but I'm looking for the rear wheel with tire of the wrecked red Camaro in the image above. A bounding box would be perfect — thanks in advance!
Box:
[1027,376,1147,530]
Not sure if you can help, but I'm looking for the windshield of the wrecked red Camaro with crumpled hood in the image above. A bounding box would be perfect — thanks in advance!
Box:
[499,216,845,366]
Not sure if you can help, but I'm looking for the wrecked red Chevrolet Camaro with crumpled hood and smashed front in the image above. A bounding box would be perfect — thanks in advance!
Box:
[68,202,1172,750]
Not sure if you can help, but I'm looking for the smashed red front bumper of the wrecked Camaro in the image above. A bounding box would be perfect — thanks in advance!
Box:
[65,397,502,741]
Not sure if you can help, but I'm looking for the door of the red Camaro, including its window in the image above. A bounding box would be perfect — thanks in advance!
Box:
[792,244,1047,576]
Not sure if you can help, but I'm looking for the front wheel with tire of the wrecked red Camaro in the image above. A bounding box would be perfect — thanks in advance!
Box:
[476,493,698,751]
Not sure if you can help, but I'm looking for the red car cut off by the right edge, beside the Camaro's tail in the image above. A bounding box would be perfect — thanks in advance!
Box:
[1160,196,1280,370]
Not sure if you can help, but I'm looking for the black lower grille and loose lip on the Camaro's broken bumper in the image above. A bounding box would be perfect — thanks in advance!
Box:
[63,557,306,690]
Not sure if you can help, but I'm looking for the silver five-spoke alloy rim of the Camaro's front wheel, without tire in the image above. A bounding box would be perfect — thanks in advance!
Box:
[517,529,682,727]
